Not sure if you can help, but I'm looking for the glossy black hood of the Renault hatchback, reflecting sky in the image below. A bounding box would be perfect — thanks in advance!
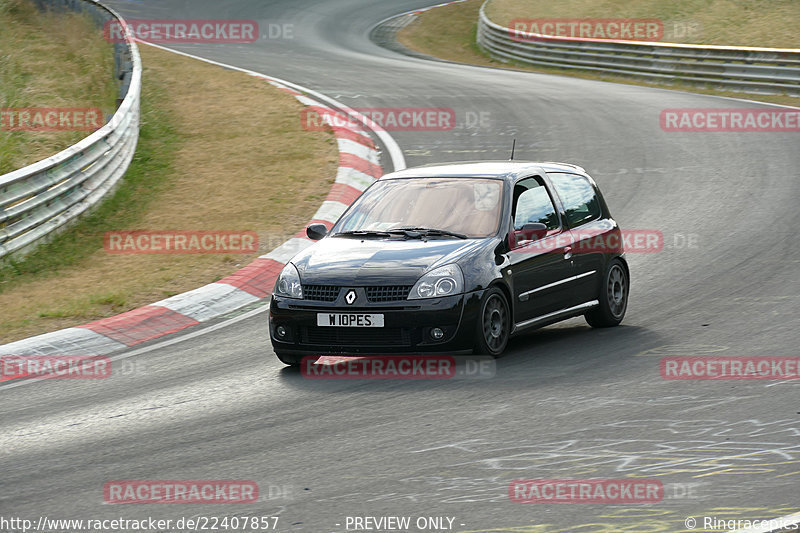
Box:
[292,237,483,285]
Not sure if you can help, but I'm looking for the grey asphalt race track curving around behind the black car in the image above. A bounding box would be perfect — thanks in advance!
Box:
[0,0,800,533]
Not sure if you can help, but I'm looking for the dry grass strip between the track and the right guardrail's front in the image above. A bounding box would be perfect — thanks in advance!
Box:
[397,0,800,106]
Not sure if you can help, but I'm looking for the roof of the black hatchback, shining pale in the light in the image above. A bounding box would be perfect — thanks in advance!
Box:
[381,160,586,180]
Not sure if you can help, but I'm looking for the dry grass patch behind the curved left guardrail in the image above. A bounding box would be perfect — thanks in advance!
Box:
[0,0,119,174]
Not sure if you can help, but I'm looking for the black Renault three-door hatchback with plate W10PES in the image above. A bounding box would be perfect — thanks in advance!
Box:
[269,161,630,365]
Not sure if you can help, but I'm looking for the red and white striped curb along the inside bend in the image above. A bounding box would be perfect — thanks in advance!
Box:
[0,43,405,357]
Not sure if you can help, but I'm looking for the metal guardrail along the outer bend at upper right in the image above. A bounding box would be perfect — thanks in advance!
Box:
[477,0,800,96]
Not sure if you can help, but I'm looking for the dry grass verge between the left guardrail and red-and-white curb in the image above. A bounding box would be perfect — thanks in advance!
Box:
[0,46,338,344]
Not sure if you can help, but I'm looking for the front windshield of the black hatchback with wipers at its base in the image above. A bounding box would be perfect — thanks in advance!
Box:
[332,178,503,238]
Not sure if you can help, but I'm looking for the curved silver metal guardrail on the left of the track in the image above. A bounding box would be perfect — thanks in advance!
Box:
[0,0,142,260]
